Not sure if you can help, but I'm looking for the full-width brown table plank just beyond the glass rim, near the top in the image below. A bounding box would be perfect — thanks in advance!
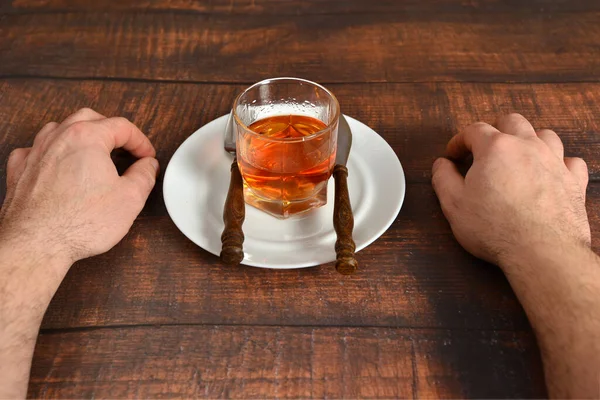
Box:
[0,9,600,83]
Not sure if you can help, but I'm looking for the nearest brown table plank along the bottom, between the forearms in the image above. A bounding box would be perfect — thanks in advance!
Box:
[29,326,545,399]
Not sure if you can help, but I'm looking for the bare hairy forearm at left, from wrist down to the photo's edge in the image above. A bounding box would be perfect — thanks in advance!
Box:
[0,241,68,398]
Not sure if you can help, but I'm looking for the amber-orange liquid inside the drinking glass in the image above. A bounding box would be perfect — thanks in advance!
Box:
[238,115,336,216]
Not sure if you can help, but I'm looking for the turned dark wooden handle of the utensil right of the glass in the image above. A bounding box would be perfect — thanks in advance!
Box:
[333,165,358,275]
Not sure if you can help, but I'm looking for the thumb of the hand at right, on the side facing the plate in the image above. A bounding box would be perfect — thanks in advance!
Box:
[431,158,465,220]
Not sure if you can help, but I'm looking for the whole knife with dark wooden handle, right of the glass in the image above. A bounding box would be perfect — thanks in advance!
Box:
[333,115,358,275]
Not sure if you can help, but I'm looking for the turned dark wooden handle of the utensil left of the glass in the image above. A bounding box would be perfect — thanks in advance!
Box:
[221,158,246,265]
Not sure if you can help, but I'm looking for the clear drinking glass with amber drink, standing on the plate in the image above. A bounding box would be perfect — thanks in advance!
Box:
[233,78,340,218]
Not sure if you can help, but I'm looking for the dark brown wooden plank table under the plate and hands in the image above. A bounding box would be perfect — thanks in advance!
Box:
[0,0,600,399]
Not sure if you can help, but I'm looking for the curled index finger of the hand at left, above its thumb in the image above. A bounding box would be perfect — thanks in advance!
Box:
[93,117,156,158]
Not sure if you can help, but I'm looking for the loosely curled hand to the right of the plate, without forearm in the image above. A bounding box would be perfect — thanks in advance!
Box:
[432,114,590,267]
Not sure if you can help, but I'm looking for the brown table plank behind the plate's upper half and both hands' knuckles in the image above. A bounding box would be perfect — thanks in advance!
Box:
[0,79,600,200]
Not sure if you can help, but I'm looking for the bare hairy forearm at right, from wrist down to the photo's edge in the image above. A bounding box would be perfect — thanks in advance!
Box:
[503,245,600,398]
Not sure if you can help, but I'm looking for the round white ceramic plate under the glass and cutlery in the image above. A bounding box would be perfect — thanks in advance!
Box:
[163,116,406,269]
